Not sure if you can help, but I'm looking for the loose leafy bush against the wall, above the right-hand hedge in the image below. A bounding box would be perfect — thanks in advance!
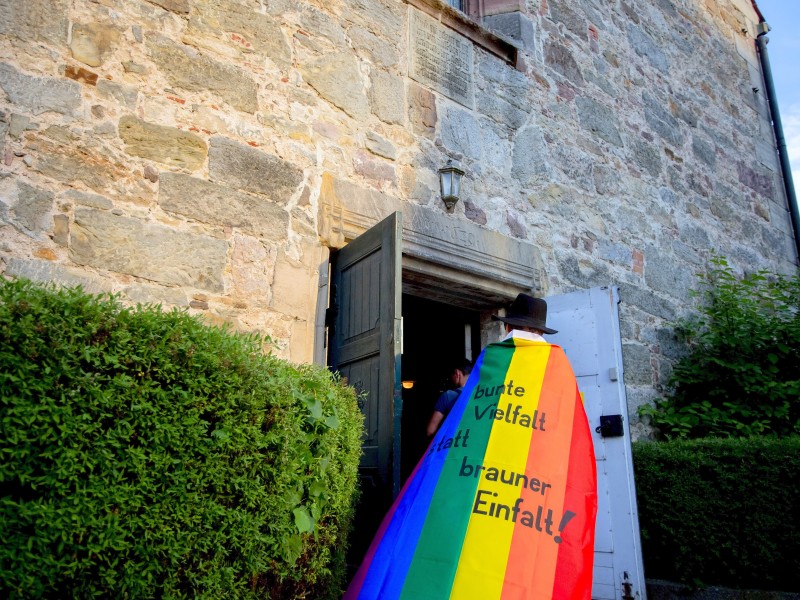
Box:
[641,257,800,438]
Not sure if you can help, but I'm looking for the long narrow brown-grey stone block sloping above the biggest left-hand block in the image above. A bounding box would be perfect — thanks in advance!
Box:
[158,173,289,242]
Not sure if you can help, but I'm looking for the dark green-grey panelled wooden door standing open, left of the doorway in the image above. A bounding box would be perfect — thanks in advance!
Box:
[327,212,402,552]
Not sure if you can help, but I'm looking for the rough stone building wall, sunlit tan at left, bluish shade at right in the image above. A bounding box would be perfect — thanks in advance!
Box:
[0,0,797,440]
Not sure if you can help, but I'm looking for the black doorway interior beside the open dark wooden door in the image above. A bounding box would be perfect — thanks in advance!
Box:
[400,294,480,482]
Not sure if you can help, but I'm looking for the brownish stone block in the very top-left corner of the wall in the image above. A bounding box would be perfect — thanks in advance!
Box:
[0,0,70,46]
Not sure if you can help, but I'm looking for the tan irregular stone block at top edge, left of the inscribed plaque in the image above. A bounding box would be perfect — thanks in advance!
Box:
[184,0,291,68]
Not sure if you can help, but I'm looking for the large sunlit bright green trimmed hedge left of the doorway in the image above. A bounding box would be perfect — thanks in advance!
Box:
[0,280,362,599]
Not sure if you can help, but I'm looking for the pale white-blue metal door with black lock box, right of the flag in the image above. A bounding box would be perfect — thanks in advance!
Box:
[547,287,646,600]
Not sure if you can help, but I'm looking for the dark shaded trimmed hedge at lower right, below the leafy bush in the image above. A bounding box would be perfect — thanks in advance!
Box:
[633,437,800,592]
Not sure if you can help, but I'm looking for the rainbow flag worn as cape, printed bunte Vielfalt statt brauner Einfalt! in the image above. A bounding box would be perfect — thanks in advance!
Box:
[344,338,597,600]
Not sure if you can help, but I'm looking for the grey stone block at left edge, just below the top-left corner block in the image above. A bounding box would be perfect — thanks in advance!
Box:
[0,63,81,115]
